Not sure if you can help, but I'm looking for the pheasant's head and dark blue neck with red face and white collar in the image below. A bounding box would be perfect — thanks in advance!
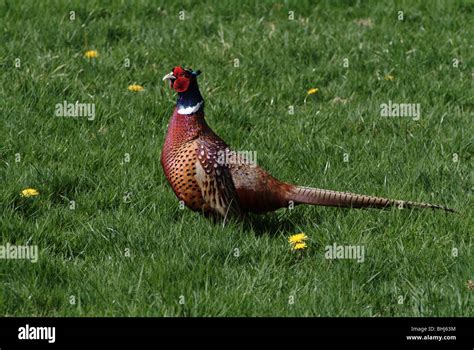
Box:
[163,66,204,114]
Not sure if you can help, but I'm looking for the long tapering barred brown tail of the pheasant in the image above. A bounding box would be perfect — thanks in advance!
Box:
[286,186,455,212]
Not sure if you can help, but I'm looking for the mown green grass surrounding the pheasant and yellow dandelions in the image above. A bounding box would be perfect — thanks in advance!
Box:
[0,0,474,316]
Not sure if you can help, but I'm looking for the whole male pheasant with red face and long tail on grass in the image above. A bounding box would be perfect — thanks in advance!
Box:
[161,66,453,219]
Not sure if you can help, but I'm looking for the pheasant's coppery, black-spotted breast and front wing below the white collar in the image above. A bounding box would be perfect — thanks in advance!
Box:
[161,109,241,216]
